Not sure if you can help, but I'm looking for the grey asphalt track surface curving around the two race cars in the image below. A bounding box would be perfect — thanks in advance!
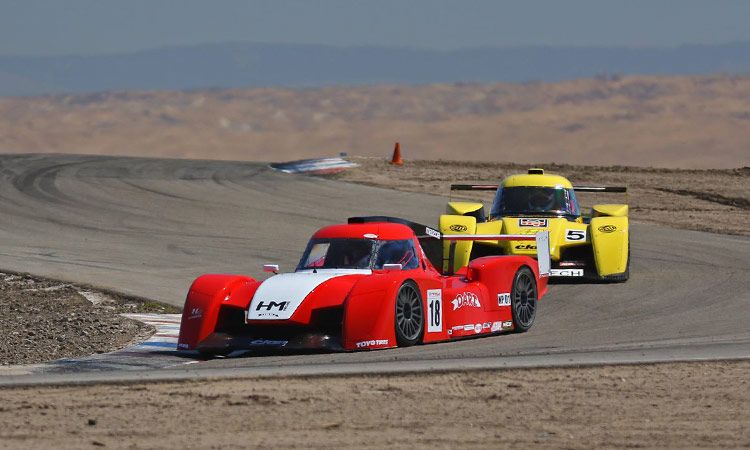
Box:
[0,155,750,376]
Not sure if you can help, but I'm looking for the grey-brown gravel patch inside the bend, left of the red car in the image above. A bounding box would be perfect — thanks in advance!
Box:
[0,272,175,366]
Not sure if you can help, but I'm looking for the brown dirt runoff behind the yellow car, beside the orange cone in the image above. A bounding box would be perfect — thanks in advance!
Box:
[335,157,750,236]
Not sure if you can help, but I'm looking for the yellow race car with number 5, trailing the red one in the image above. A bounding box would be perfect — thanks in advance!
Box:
[440,169,630,282]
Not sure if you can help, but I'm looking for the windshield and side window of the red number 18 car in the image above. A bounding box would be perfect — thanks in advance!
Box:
[297,238,419,270]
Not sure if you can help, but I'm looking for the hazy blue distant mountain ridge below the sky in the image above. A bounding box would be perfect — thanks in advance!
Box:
[0,42,750,96]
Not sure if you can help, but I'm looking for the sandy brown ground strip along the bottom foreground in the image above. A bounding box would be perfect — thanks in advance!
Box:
[0,361,750,449]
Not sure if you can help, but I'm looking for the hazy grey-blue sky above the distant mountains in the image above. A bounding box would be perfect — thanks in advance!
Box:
[0,0,750,55]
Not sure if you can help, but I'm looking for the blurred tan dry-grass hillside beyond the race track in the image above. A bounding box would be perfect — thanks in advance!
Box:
[0,76,750,168]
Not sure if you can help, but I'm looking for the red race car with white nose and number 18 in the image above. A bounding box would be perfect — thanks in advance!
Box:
[178,217,550,354]
